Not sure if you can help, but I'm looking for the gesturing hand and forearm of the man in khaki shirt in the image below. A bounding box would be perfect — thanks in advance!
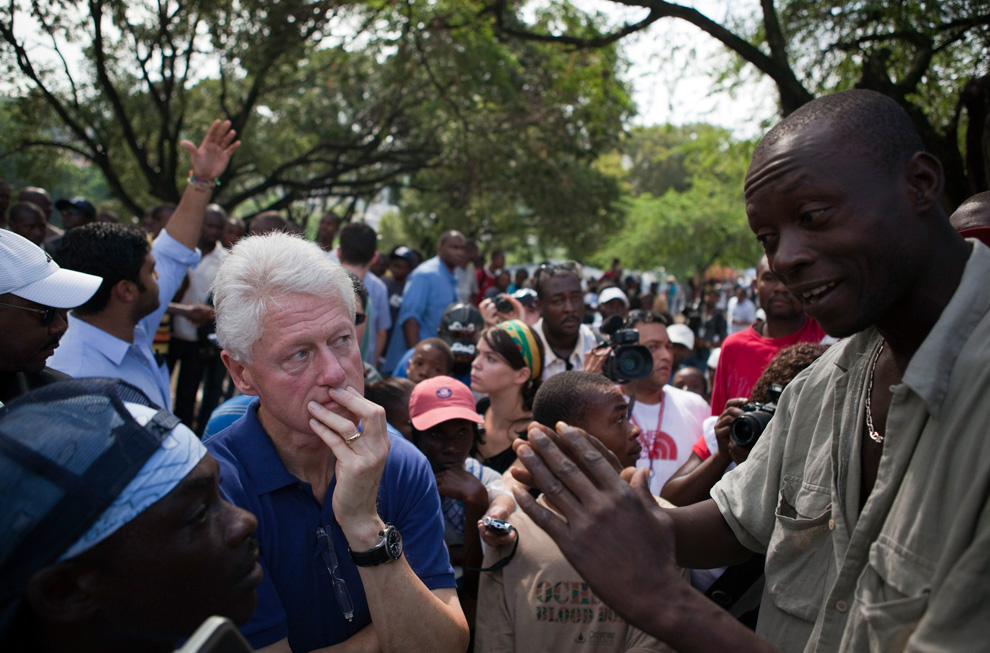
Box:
[513,422,772,651]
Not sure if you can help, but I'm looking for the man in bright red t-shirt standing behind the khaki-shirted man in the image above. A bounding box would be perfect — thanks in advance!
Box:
[712,256,826,416]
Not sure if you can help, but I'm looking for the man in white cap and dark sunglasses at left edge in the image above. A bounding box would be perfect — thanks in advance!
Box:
[0,230,103,405]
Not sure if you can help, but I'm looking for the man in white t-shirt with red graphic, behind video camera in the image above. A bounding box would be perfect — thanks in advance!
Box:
[613,311,710,495]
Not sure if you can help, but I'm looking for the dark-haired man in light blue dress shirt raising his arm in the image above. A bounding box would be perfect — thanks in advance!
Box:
[49,120,240,409]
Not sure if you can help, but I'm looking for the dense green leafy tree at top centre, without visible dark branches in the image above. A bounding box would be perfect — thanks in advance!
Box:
[390,0,632,257]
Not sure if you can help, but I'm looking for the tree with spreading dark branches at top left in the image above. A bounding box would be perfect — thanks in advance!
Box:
[0,0,420,219]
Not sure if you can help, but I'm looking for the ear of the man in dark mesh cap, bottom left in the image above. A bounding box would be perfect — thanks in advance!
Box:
[25,561,99,624]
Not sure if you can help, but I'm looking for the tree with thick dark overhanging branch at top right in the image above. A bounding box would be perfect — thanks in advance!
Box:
[492,0,990,205]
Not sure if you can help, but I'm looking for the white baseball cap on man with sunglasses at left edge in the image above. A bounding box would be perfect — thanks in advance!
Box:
[0,229,103,308]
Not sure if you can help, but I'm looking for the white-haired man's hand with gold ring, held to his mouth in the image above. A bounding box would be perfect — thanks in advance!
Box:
[308,387,391,546]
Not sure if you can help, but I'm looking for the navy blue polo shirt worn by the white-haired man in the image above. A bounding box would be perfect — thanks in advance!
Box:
[206,402,454,651]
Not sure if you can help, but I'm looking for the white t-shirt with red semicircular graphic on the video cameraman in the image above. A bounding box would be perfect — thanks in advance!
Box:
[632,385,711,495]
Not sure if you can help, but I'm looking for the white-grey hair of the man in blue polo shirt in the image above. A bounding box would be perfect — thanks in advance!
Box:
[213,231,355,363]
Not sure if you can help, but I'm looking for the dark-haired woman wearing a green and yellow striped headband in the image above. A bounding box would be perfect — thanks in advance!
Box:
[471,320,543,473]
